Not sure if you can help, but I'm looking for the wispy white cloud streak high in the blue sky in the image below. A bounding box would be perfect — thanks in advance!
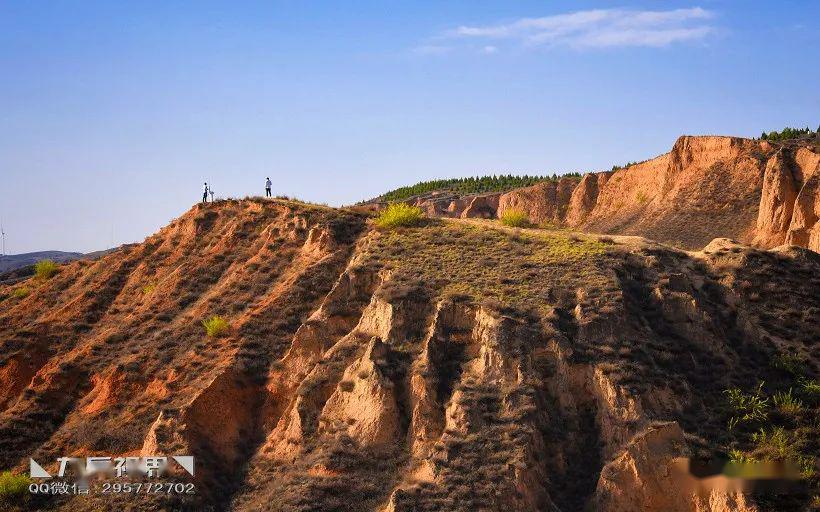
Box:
[439,7,716,53]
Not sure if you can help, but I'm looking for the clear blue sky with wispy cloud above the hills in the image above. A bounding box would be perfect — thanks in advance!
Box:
[0,0,820,253]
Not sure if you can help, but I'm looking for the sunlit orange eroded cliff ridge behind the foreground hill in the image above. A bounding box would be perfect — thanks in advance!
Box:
[372,136,820,251]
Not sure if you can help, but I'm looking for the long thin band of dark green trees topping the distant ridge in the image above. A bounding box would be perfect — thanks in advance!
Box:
[366,172,581,201]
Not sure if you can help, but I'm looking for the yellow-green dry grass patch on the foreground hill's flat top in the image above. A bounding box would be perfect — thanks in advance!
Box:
[365,222,611,307]
